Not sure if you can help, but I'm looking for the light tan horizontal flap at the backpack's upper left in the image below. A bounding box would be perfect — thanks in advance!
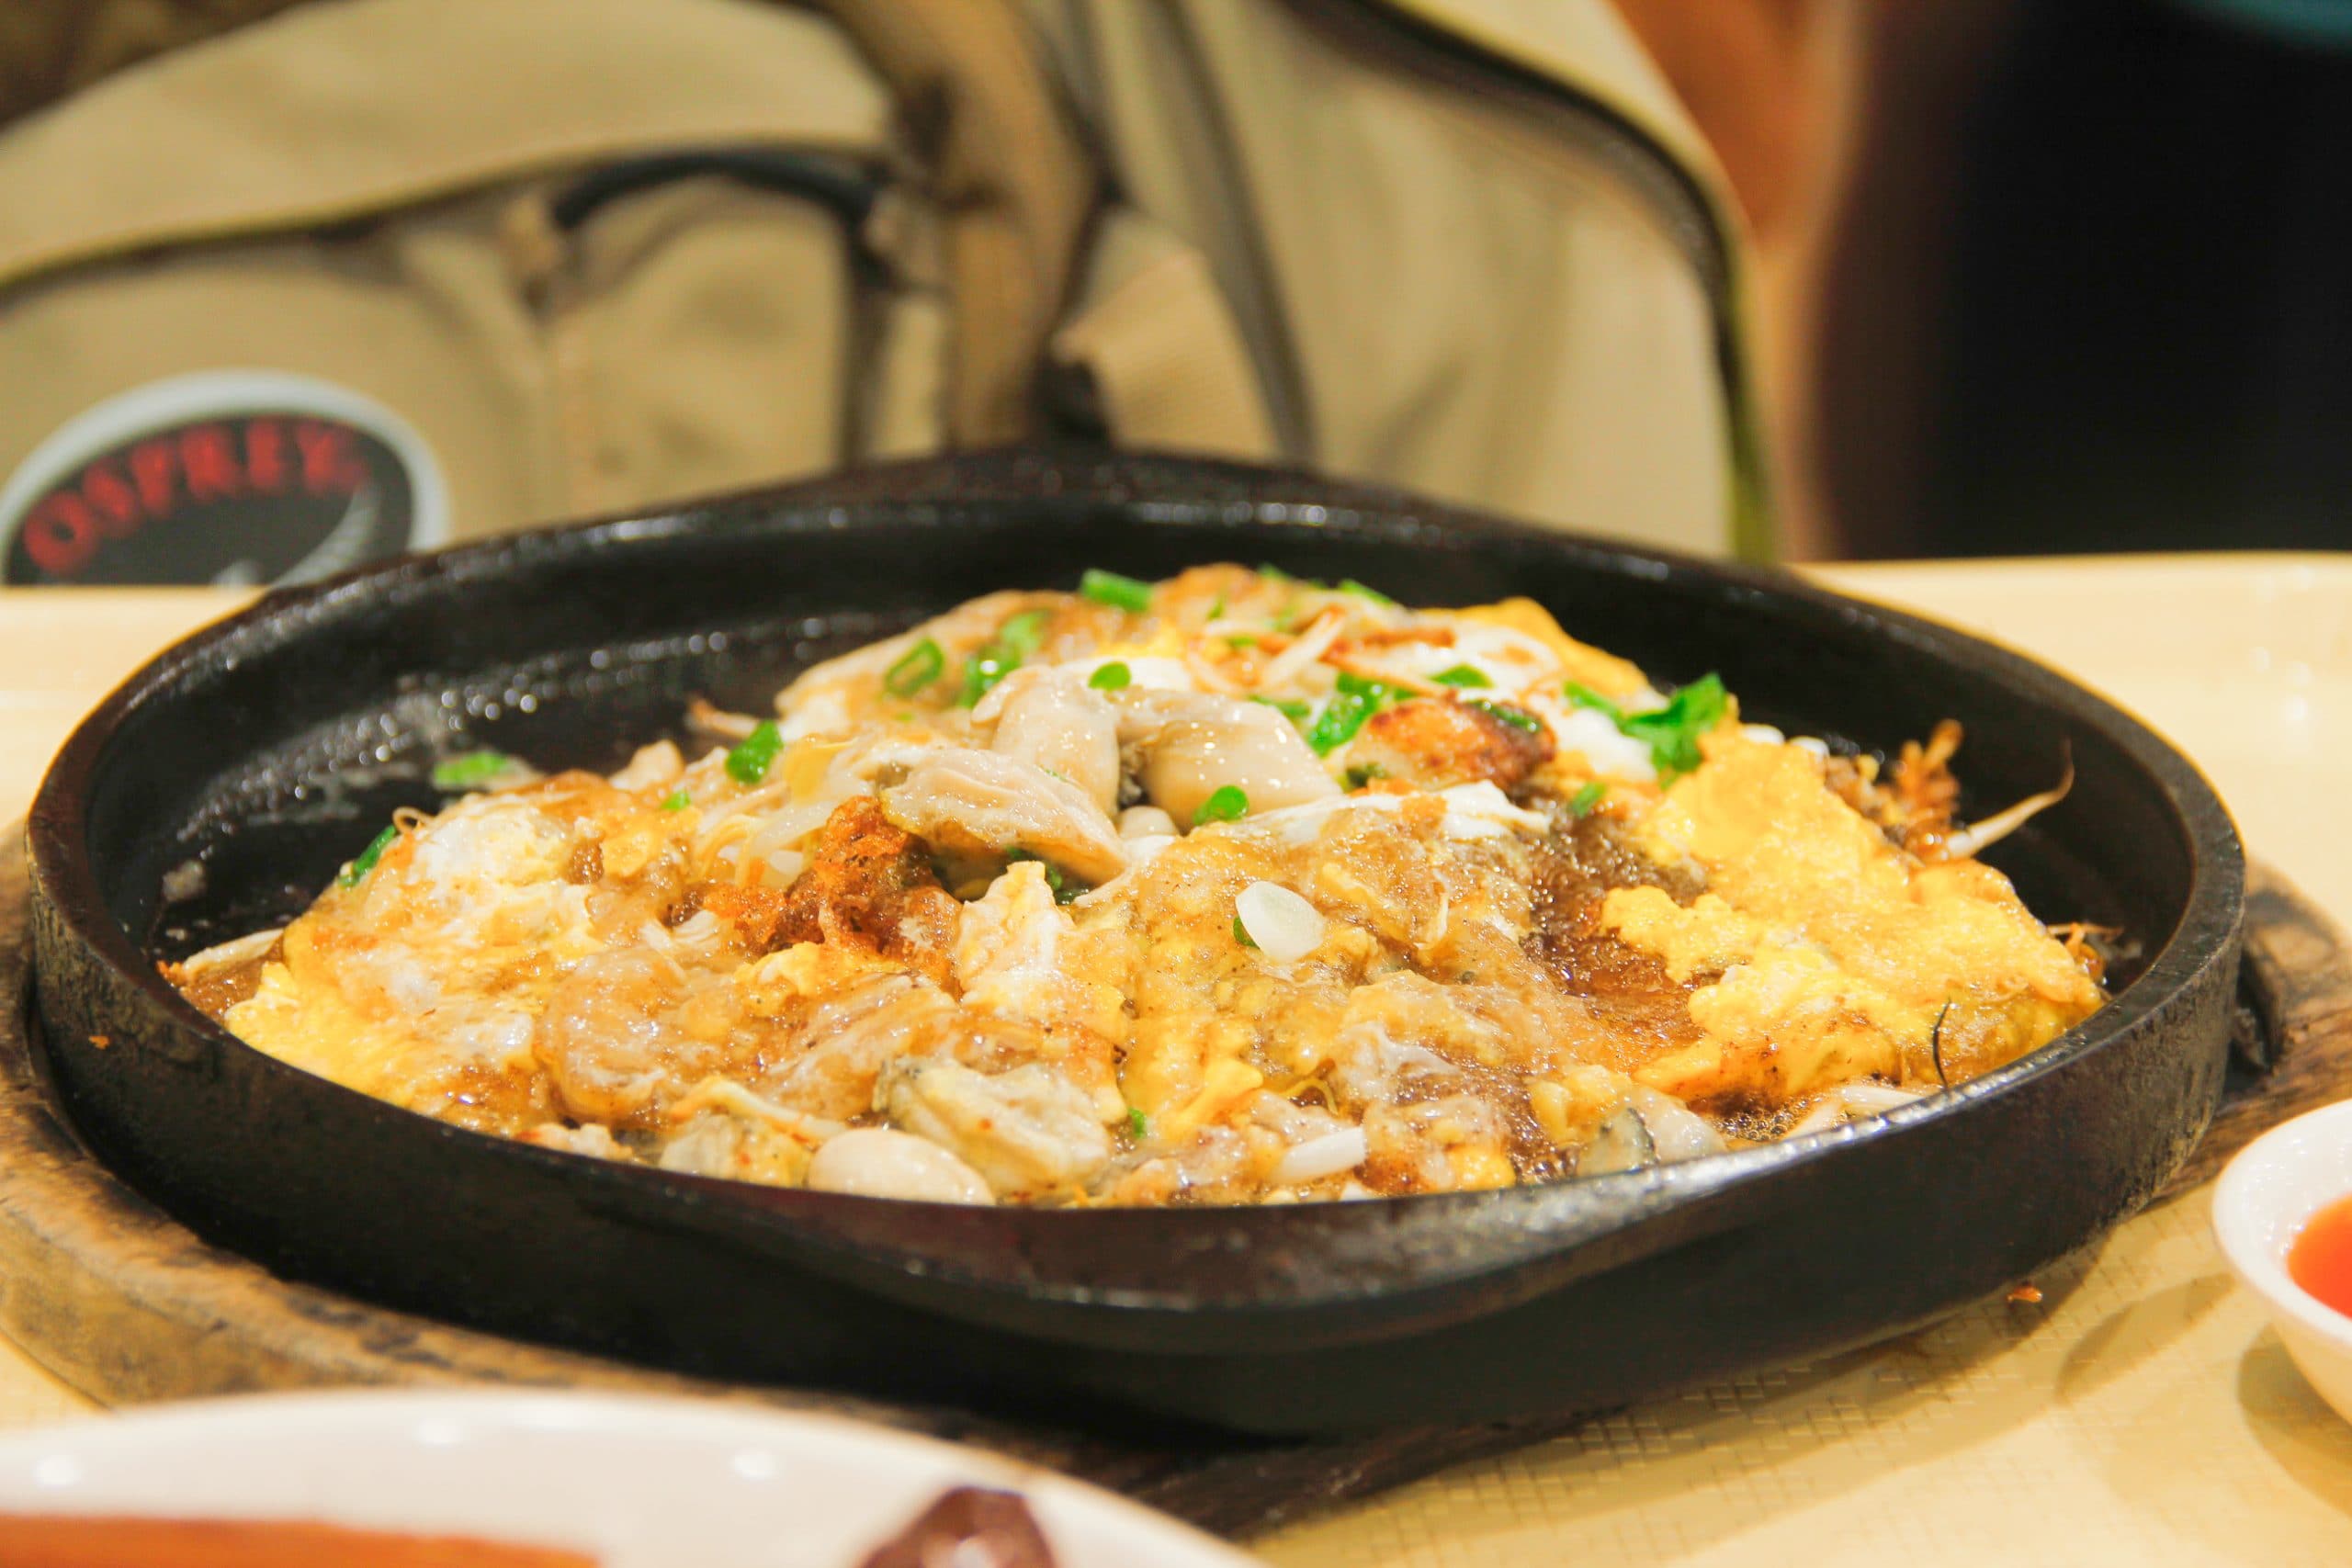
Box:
[0,0,894,297]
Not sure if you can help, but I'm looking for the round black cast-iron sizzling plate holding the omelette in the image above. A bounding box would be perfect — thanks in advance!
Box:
[30,456,2244,1432]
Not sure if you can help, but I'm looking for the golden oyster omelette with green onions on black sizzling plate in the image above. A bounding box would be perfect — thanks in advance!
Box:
[167,567,2103,1206]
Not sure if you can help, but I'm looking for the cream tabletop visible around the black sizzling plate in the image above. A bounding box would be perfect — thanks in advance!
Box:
[0,555,2352,1568]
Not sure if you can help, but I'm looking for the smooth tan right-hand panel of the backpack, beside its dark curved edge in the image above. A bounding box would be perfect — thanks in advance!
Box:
[1033,0,1736,550]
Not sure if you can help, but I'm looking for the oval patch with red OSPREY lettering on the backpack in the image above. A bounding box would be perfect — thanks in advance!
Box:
[0,371,449,585]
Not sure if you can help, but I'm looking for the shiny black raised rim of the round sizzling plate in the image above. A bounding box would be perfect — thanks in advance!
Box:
[26,449,2244,1321]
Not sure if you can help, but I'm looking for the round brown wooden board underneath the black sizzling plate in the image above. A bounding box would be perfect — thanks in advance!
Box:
[0,835,2352,1535]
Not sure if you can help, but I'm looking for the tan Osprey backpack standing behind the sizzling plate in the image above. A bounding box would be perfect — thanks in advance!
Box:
[0,0,1764,583]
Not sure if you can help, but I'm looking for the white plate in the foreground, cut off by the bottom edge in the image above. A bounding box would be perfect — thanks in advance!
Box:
[0,1392,1251,1568]
